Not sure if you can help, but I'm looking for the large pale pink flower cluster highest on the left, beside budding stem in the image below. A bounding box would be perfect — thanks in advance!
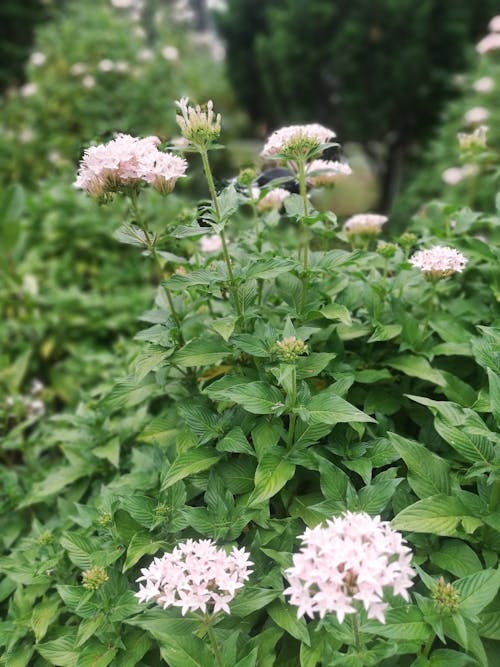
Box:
[75,134,187,198]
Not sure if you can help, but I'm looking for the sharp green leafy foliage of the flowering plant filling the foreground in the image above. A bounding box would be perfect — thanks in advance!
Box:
[0,99,500,667]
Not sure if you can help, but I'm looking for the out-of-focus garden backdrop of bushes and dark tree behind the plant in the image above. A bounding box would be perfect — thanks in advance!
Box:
[0,0,500,408]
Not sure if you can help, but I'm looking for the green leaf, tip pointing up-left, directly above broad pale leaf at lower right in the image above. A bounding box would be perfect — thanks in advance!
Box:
[388,433,451,498]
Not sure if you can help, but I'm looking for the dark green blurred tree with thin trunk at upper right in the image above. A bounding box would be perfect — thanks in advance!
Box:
[218,0,498,207]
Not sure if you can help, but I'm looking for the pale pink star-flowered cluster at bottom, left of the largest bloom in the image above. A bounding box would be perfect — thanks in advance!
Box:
[135,539,253,616]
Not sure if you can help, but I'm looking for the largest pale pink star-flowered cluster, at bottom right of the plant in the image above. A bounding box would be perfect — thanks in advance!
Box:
[284,512,415,623]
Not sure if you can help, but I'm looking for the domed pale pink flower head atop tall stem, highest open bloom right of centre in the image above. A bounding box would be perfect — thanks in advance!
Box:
[261,123,336,158]
